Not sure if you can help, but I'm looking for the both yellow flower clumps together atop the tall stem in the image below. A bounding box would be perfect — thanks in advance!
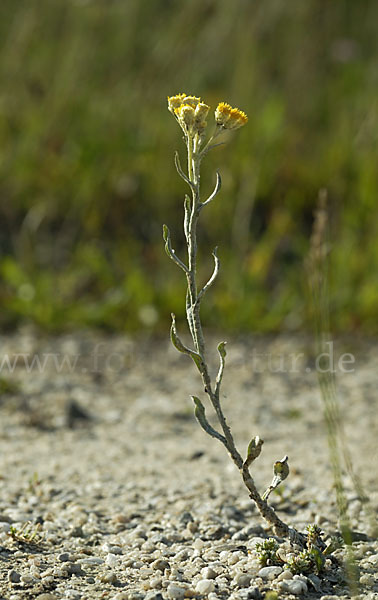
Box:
[168,94,248,135]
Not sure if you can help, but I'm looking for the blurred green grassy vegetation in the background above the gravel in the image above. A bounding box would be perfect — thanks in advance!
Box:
[0,0,378,333]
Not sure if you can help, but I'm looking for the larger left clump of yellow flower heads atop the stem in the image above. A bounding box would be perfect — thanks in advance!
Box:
[168,94,210,134]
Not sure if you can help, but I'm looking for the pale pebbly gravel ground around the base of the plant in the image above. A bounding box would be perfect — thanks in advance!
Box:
[0,331,378,600]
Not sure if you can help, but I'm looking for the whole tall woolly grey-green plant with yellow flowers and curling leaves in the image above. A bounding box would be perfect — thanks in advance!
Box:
[163,94,307,547]
